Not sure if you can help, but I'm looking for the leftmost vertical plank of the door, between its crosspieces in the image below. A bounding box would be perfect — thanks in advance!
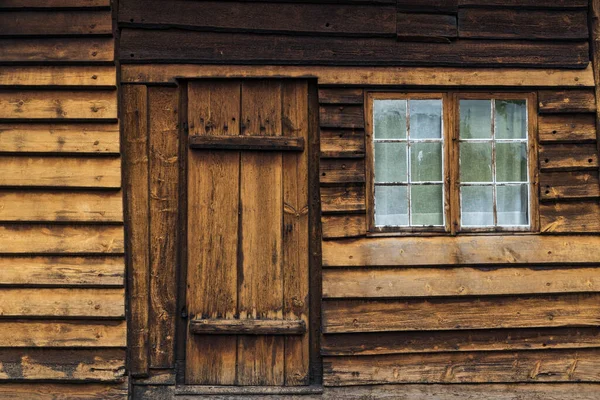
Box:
[186,82,240,385]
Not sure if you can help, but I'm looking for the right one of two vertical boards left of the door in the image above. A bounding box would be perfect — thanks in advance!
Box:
[148,87,179,368]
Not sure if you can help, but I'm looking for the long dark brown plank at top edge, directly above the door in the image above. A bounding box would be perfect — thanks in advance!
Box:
[119,0,396,36]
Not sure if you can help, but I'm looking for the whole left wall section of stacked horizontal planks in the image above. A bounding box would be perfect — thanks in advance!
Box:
[0,0,127,399]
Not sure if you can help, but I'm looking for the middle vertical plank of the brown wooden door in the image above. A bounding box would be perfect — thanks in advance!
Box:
[238,81,284,385]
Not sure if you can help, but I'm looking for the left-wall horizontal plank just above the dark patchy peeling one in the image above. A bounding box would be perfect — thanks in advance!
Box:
[0,321,127,346]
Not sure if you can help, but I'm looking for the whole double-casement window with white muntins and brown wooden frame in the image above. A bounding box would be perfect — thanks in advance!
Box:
[367,93,536,233]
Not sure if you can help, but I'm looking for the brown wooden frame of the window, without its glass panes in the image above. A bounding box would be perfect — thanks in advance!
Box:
[365,91,539,236]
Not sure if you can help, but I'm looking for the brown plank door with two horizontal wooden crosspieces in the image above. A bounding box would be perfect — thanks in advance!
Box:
[186,80,309,385]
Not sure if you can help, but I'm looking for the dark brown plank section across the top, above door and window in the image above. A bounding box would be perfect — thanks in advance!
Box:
[119,0,589,68]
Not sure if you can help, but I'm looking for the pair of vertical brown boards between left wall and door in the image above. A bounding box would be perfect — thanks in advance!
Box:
[122,85,180,378]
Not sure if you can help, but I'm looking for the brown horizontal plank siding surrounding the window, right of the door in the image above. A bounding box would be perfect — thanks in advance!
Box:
[319,87,600,386]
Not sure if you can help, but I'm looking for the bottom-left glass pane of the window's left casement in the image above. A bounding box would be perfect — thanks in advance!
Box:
[375,186,408,226]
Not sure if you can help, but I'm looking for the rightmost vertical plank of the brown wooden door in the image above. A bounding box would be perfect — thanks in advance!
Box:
[282,81,310,386]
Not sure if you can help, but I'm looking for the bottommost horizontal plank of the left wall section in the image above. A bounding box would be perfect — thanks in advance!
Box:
[0,383,128,400]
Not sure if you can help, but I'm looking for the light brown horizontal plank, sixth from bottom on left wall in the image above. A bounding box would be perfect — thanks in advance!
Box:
[0,224,124,254]
